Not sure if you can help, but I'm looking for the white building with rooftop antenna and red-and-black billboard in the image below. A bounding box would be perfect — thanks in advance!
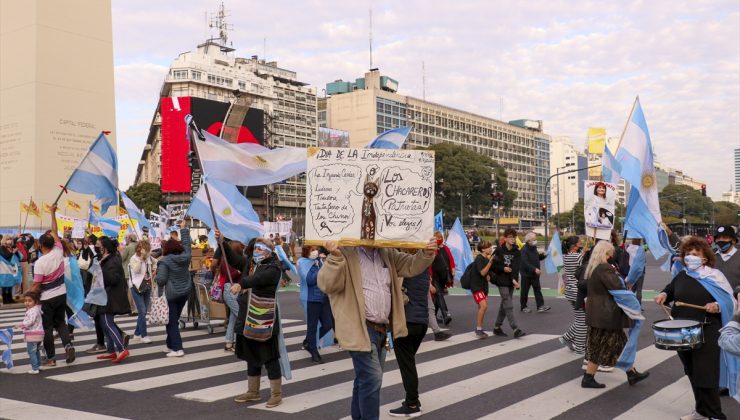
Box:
[134,6,318,228]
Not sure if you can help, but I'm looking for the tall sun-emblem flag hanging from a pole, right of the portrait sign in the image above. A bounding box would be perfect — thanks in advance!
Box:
[616,98,667,259]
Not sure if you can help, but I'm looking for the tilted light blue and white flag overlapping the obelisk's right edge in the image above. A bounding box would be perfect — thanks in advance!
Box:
[67,133,118,214]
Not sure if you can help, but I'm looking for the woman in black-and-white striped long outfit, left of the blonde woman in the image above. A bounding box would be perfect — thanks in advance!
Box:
[558,236,587,354]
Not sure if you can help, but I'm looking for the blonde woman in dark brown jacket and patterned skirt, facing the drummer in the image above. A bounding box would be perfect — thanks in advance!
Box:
[581,241,649,388]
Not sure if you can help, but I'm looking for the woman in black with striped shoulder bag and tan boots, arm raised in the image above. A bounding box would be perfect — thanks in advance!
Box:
[216,230,282,408]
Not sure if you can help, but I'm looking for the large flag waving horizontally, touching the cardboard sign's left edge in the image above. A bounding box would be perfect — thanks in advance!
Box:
[197,131,308,187]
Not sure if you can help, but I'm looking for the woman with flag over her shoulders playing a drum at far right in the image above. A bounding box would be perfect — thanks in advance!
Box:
[655,237,737,420]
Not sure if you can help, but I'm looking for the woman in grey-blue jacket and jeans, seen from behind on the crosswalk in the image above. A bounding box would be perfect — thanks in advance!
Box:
[156,220,193,357]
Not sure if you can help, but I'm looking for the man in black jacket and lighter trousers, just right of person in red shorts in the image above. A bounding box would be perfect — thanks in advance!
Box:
[493,228,525,338]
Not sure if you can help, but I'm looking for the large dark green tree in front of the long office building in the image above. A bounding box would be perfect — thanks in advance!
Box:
[428,143,517,223]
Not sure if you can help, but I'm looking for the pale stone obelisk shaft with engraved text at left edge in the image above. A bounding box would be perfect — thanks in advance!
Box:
[0,0,116,229]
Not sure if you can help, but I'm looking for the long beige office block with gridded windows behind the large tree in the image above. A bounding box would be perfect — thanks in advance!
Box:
[319,69,550,227]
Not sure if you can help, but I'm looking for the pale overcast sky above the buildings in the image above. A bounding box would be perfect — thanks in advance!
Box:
[112,0,740,197]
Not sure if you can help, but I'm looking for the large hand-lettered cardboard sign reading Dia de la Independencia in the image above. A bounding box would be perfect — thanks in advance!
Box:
[306,148,434,248]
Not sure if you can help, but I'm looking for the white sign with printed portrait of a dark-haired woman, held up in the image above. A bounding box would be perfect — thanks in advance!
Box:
[583,181,617,239]
